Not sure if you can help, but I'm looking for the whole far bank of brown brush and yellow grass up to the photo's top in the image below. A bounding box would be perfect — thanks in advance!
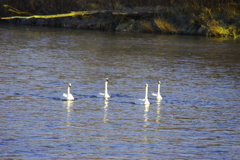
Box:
[0,0,240,38]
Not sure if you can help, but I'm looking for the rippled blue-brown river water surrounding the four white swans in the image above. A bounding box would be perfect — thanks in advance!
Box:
[0,25,240,159]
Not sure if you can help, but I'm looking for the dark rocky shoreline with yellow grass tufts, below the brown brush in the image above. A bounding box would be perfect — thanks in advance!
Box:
[0,2,240,38]
